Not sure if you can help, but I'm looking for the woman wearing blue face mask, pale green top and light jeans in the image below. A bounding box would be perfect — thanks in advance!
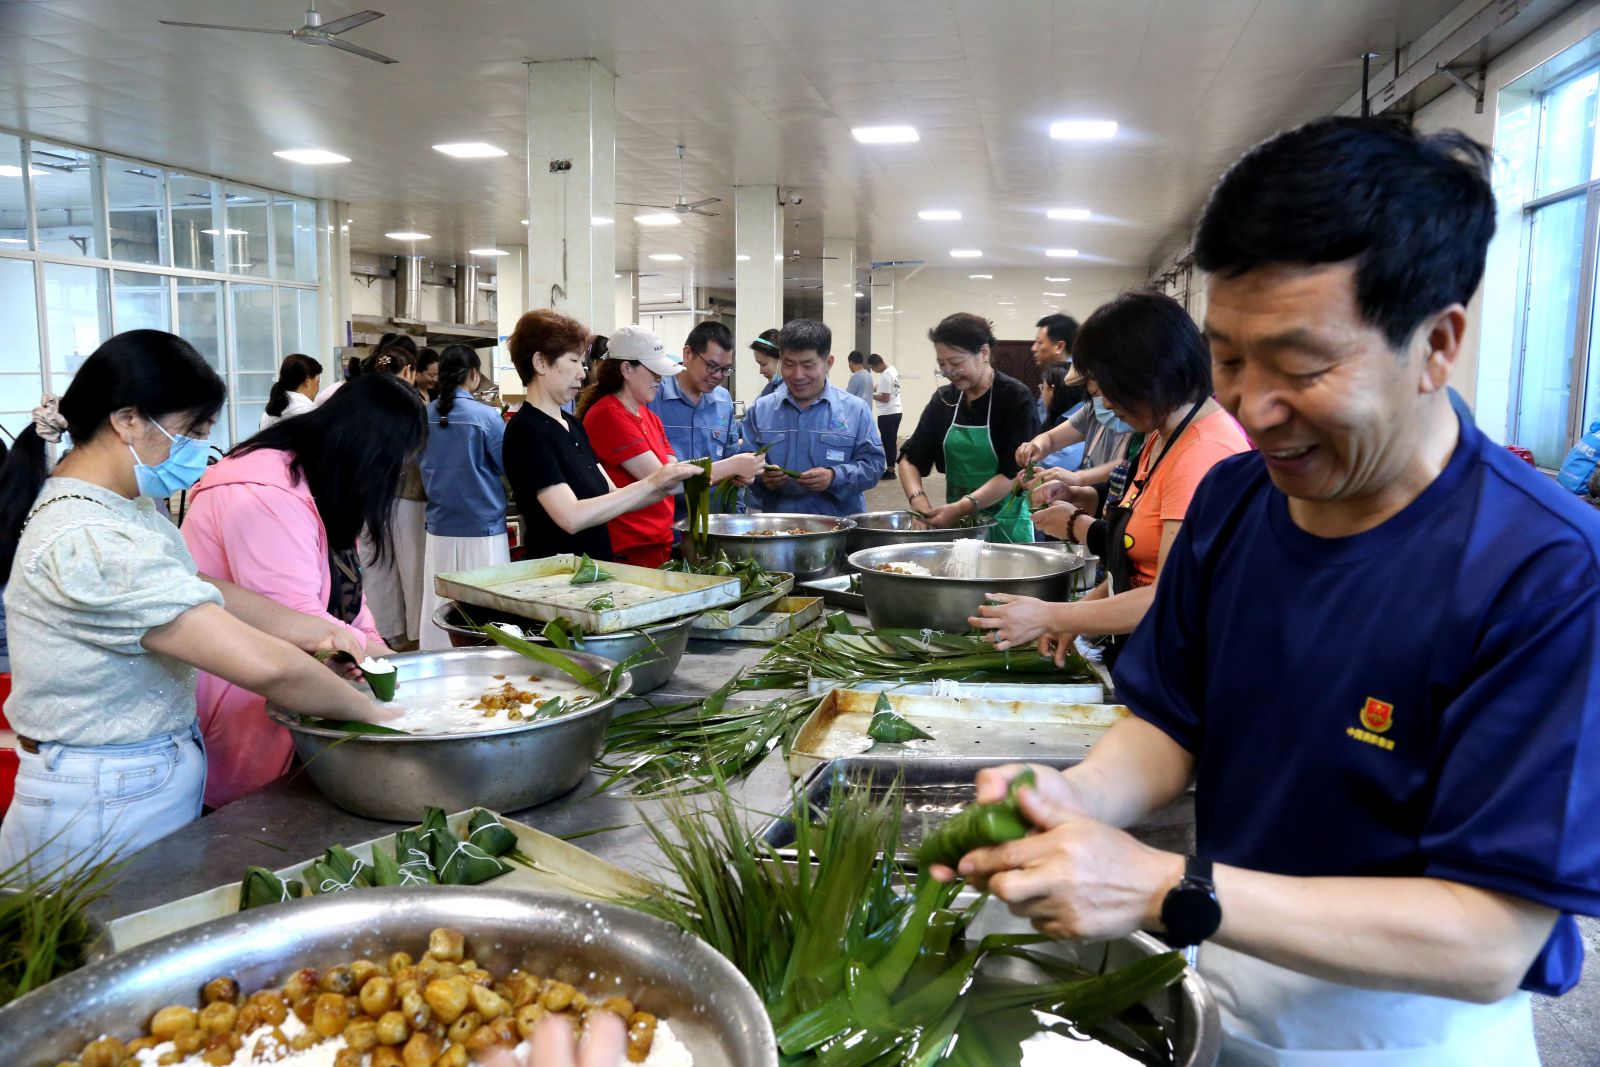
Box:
[0,330,394,875]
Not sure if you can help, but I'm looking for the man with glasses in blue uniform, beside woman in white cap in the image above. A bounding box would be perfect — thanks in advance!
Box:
[650,322,739,518]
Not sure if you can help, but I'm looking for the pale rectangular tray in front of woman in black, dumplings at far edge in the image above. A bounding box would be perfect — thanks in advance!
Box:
[434,553,739,633]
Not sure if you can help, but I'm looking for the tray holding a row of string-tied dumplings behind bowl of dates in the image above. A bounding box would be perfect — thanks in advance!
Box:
[107,808,651,952]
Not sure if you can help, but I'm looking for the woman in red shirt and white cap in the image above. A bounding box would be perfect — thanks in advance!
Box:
[578,326,683,568]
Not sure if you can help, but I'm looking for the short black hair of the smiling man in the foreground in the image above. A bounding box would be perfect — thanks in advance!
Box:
[1195,117,1494,349]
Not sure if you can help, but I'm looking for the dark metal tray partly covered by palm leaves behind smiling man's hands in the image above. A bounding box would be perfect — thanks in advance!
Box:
[757,757,1194,867]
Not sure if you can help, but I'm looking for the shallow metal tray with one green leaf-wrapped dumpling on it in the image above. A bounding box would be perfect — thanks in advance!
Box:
[787,688,1128,777]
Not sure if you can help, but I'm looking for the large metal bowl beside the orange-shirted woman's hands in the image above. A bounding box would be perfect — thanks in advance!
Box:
[850,541,1083,633]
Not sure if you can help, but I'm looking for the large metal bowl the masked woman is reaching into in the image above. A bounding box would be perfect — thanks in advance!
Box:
[267,648,630,822]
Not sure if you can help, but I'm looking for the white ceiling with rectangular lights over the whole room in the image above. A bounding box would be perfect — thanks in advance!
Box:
[0,0,1456,285]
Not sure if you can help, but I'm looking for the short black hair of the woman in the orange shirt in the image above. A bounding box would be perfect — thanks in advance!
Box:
[1072,291,1211,422]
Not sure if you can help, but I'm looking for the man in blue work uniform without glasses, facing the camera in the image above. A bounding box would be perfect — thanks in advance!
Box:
[744,318,883,515]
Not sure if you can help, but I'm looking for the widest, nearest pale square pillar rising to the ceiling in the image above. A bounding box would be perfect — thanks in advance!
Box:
[528,59,616,334]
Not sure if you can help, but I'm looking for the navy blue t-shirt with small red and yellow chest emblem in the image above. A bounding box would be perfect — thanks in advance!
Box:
[1115,424,1600,993]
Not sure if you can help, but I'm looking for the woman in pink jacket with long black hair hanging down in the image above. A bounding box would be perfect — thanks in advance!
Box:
[182,374,427,808]
